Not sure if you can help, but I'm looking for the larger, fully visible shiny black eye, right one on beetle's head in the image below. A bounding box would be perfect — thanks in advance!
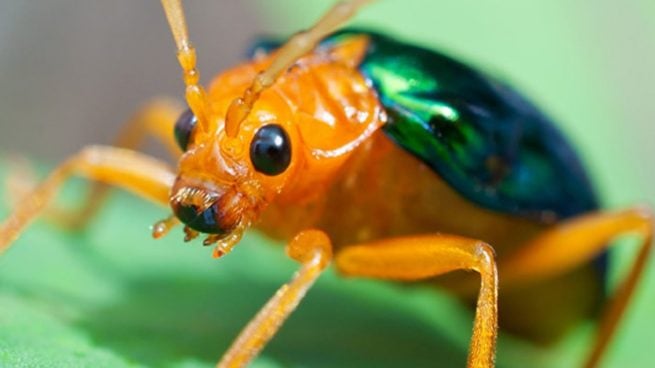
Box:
[250,124,291,176]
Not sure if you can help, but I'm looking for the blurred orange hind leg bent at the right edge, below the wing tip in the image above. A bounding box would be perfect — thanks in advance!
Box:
[500,208,654,367]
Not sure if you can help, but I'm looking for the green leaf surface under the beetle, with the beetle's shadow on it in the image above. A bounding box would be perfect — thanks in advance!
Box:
[0,168,644,368]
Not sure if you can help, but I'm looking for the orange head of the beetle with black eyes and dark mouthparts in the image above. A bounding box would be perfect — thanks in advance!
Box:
[170,68,303,252]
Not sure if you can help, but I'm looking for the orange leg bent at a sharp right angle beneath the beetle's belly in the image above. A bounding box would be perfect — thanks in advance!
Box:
[335,235,498,367]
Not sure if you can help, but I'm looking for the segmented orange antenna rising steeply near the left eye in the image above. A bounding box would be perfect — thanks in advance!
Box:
[161,0,216,133]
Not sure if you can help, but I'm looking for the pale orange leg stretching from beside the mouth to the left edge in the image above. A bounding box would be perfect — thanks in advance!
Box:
[0,146,175,254]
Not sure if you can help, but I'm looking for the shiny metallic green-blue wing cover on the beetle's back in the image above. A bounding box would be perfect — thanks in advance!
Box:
[334,31,598,220]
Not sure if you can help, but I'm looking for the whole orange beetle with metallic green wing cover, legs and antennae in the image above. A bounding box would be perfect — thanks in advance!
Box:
[0,1,651,366]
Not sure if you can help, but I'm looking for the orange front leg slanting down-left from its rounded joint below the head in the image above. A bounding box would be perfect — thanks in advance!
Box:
[217,230,332,368]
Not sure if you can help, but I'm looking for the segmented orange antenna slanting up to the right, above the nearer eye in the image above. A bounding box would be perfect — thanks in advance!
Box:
[223,0,373,138]
